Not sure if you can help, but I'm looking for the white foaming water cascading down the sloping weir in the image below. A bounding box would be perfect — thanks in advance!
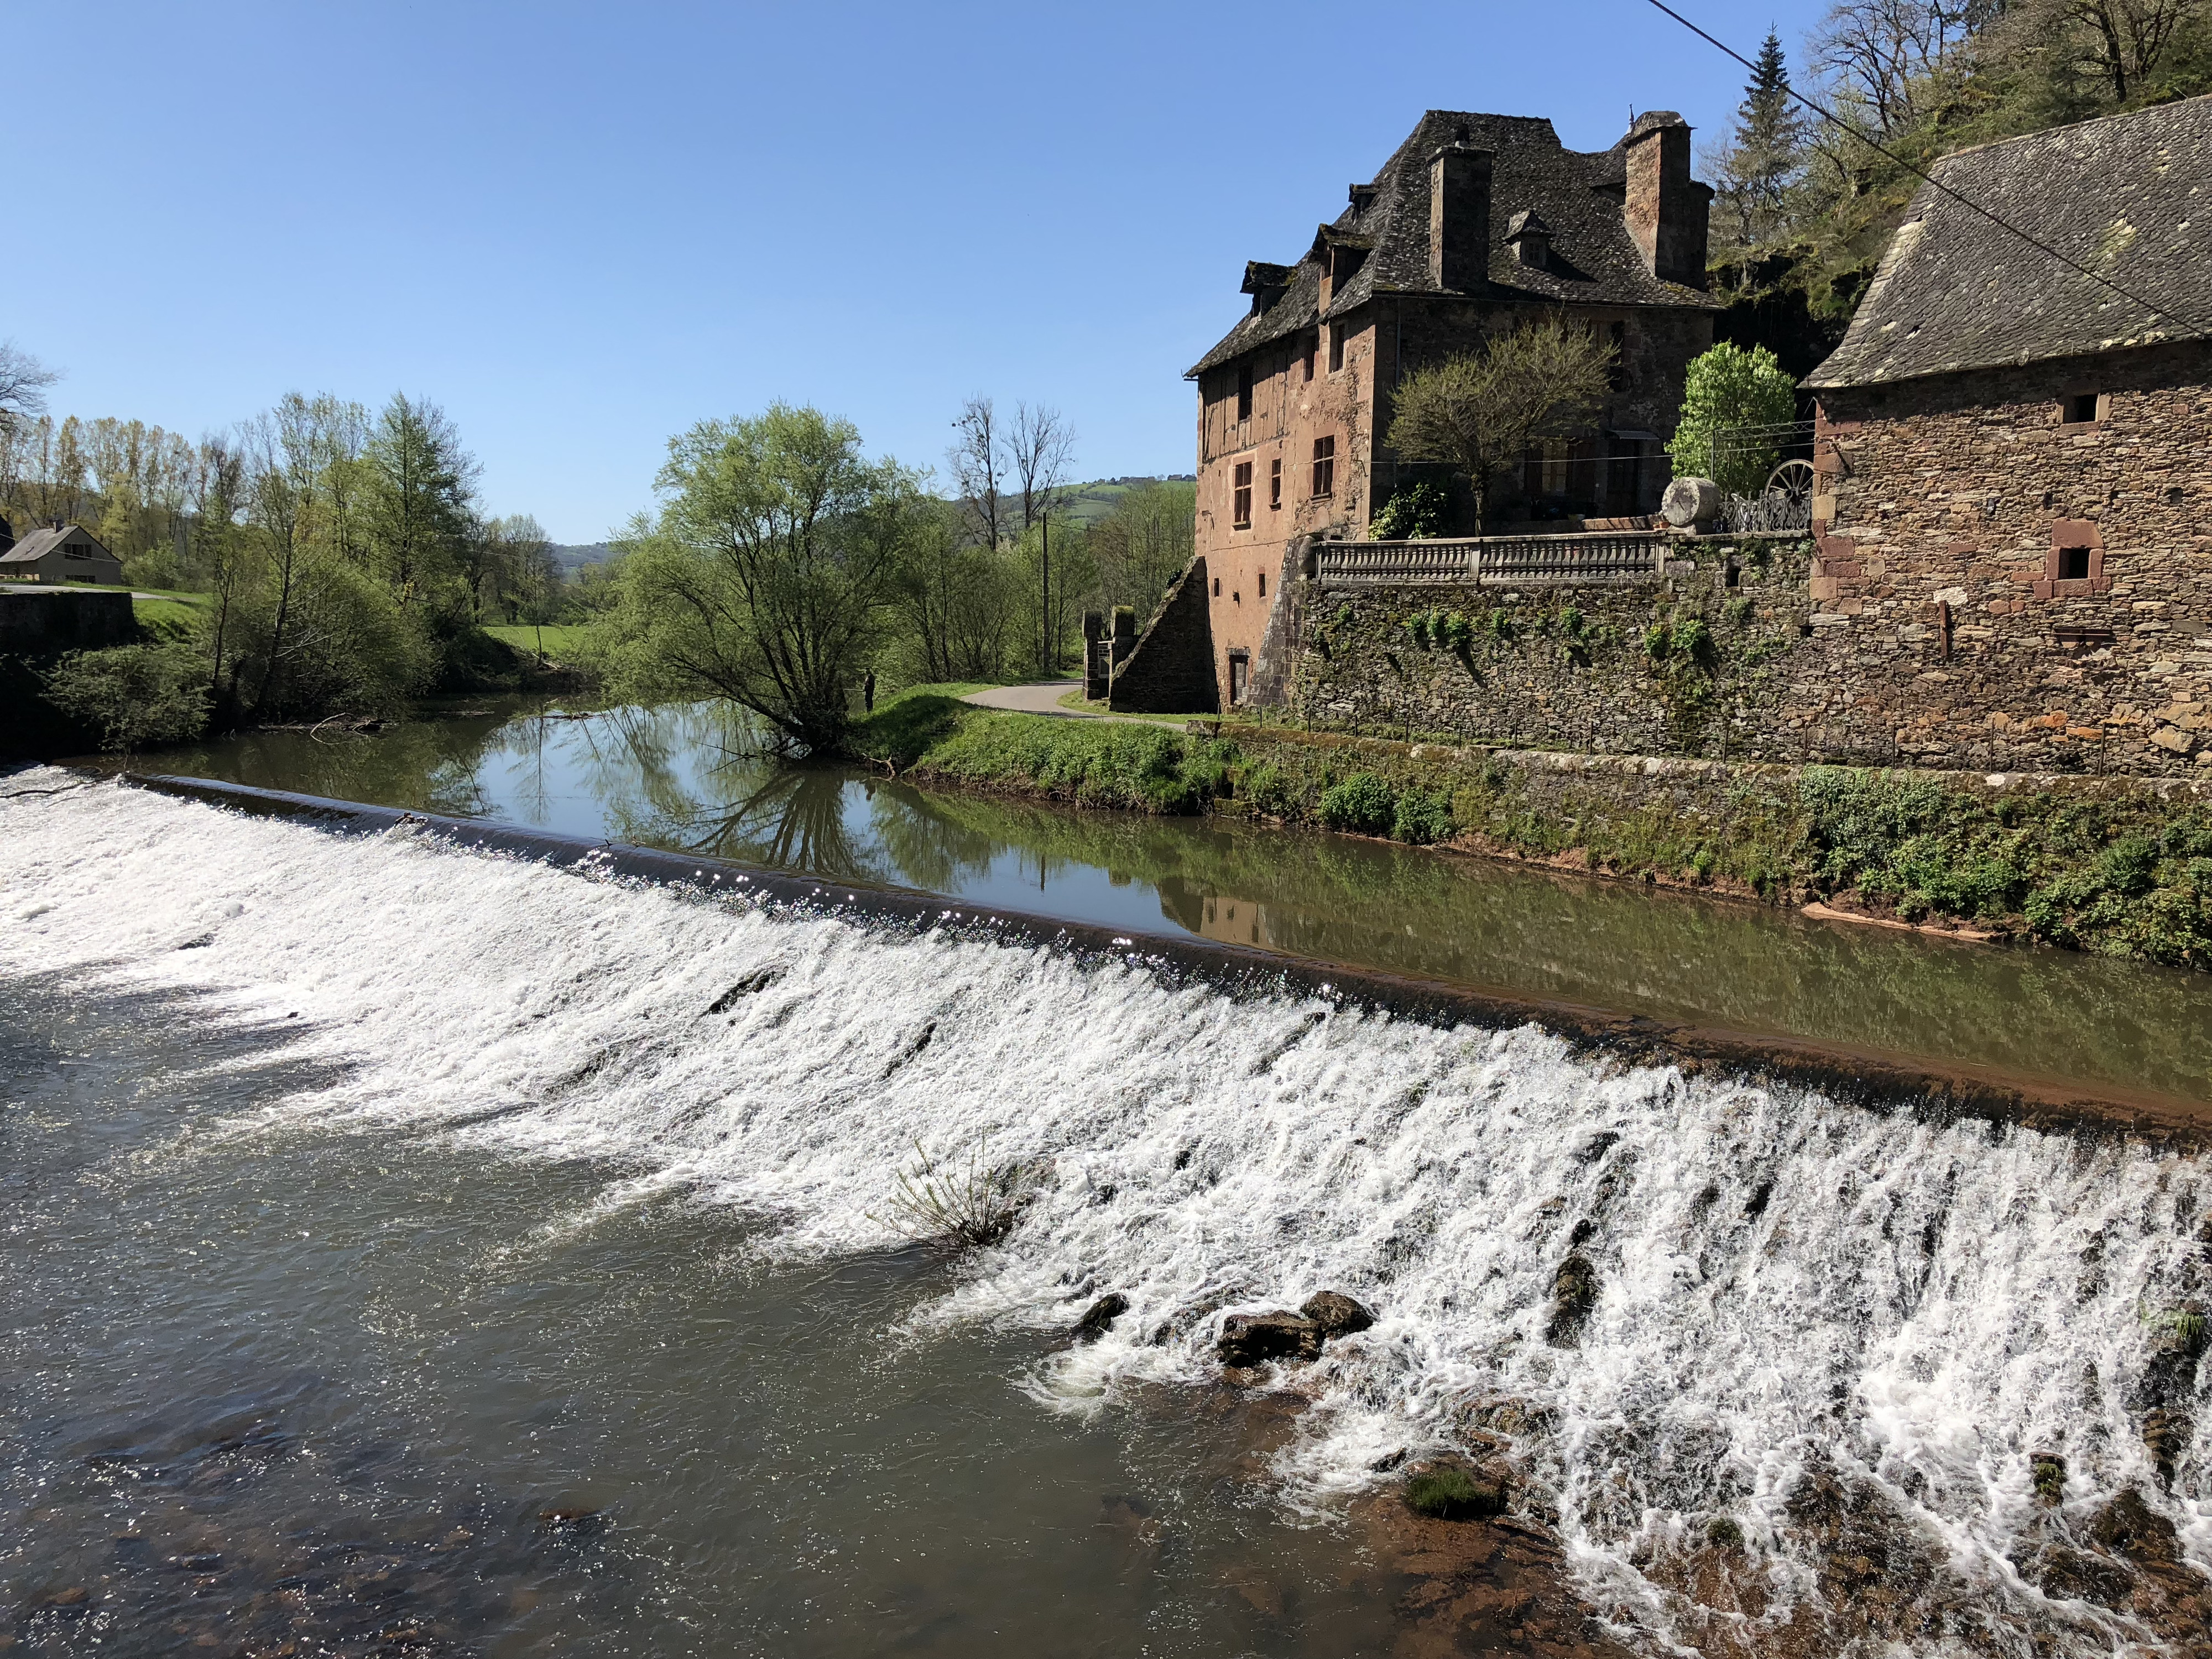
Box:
[13,772,2212,1652]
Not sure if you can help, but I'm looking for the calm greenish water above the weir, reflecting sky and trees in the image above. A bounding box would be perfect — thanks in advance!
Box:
[117,703,2212,1102]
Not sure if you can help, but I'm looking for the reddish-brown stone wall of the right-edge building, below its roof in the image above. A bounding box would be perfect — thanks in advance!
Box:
[1807,343,2212,774]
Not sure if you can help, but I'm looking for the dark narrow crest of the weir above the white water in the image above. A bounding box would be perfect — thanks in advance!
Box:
[112,772,2212,1150]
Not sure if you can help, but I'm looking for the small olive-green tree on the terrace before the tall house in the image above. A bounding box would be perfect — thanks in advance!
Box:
[1389,316,1613,524]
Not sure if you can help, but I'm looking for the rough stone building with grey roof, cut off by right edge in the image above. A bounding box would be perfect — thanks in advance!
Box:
[1807,97,2212,772]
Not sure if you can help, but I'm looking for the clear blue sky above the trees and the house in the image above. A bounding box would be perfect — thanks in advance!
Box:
[0,0,1818,542]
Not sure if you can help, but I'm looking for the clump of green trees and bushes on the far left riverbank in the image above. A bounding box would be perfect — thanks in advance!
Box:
[0,383,580,748]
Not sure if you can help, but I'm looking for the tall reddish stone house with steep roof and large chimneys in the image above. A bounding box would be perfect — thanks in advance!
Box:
[1186,111,1714,708]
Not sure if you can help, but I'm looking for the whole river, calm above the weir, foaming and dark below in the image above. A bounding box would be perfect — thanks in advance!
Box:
[0,695,2212,1655]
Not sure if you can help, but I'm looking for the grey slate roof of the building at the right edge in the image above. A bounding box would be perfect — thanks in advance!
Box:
[1805,97,2212,387]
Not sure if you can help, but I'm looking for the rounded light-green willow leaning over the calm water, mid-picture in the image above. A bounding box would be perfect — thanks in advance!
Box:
[597,403,925,754]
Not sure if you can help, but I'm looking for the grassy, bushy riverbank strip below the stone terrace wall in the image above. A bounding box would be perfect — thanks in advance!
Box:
[854,688,2212,969]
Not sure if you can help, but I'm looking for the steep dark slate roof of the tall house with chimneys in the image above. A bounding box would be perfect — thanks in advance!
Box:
[1183,108,1719,378]
